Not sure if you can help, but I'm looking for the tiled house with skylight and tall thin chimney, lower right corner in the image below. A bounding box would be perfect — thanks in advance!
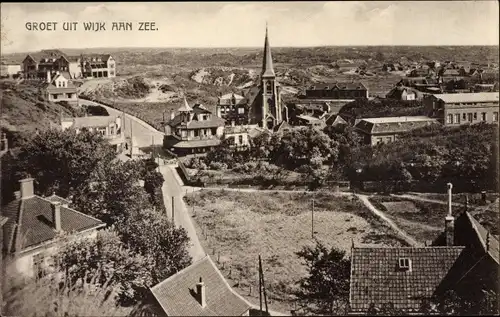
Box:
[349,184,500,315]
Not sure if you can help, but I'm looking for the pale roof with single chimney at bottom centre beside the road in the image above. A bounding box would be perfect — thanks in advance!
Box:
[151,256,250,316]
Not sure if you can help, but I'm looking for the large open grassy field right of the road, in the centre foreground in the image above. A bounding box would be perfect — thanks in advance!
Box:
[186,190,404,312]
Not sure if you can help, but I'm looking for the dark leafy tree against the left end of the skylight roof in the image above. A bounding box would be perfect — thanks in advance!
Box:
[297,241,351,315]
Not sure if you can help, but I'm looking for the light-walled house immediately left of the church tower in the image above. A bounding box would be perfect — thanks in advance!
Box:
[216,93,251,125]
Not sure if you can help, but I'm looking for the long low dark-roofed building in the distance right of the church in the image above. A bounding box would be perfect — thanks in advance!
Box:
[305,82,368,100]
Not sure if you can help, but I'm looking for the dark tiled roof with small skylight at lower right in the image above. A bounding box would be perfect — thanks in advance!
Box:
[349,247,465,312]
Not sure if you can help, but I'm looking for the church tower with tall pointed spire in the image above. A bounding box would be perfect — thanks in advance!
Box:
[260,24,283,129]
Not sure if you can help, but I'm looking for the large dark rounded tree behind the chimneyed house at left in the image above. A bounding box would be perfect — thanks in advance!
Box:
[18,130,115,197]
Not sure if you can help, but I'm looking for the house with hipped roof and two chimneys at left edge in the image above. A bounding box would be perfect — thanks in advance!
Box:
[2,178,105,278]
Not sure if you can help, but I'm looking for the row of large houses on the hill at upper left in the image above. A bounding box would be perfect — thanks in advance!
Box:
[1,50,116,80]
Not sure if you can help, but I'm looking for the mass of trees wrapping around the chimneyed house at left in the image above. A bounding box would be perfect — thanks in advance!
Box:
[2,130,191,314]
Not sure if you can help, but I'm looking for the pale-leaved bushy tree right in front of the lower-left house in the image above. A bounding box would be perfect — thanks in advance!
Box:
[57,229,153,305]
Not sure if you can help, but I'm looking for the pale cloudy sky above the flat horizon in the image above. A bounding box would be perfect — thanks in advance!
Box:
[1,0,499,54]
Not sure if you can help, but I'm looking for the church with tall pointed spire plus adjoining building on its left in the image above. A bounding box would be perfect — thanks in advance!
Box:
[217,26,288,131]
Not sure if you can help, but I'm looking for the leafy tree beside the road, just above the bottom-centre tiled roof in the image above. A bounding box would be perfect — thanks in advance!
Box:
[116,210,192,284]
